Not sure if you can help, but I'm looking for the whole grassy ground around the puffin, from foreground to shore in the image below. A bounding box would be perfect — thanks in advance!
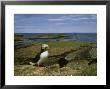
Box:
[14,33,97,76]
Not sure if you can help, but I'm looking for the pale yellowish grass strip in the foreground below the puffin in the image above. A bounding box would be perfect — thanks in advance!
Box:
[14,60,97,76]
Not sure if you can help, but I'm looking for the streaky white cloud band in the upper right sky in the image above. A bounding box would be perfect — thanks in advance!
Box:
[48,14,97,23]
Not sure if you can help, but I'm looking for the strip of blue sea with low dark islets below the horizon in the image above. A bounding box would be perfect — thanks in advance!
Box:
[15,33,97,46]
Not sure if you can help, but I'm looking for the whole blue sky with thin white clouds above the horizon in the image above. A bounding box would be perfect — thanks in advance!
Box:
[14,14,97,33]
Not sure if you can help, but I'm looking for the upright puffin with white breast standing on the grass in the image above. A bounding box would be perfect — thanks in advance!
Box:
[36,44,49,67]
